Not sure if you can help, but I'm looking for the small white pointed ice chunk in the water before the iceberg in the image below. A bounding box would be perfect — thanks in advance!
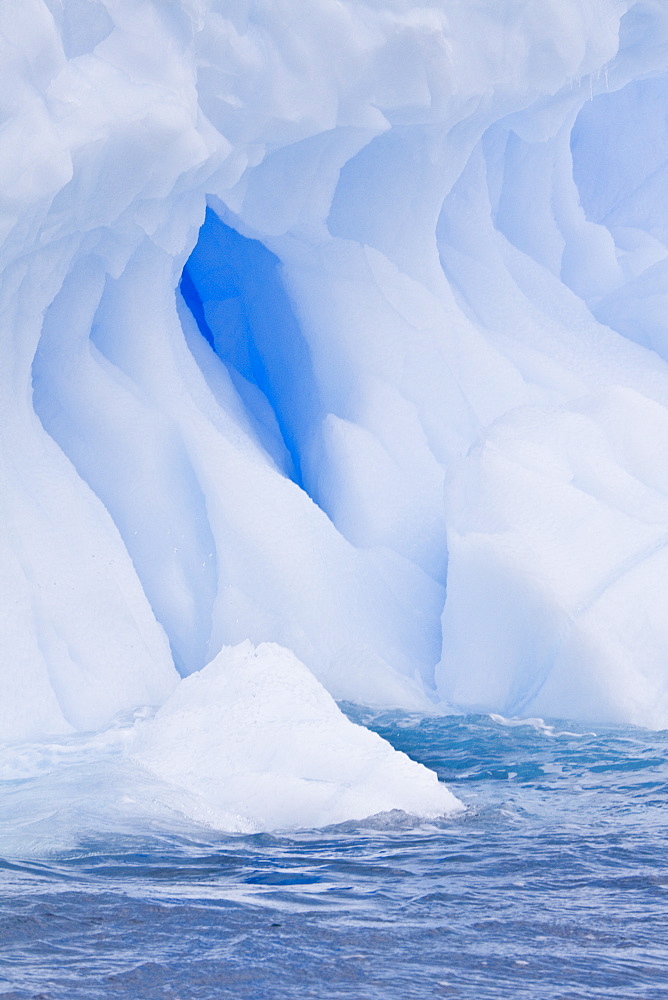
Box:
[133,641,462,831]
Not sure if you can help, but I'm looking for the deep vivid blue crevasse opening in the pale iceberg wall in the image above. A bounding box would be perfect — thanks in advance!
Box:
[179,208,318,488]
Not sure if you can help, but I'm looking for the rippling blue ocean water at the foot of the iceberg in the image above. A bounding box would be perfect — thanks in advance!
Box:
[0,706,668,1000]
